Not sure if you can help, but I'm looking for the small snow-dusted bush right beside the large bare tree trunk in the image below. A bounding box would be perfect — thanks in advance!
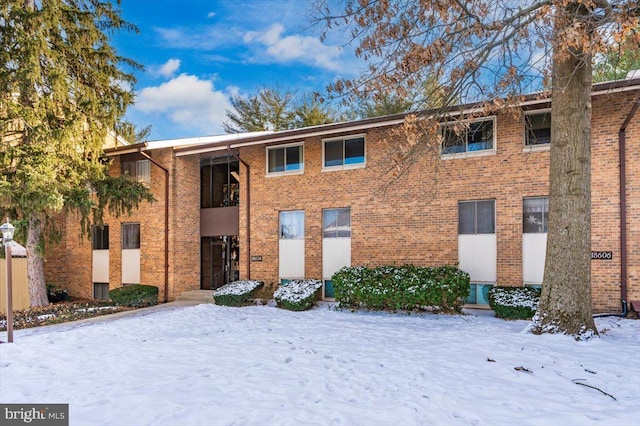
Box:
[489,286,541,319]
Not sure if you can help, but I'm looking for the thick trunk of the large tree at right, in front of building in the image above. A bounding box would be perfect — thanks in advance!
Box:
[532,2,598,339]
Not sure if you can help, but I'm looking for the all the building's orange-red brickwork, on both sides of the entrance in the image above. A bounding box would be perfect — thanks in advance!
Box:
[46,87,640,312]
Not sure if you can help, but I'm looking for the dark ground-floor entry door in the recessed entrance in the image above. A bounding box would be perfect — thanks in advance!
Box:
[200,237,229,290]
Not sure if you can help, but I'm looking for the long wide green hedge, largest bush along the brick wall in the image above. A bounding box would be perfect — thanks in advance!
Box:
[331,265,470,312]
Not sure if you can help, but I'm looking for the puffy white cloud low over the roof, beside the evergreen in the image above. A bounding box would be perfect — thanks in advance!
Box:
[135,74,231,134]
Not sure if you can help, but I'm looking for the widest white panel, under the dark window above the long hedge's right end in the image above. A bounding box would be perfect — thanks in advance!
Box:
[458,234,497,283]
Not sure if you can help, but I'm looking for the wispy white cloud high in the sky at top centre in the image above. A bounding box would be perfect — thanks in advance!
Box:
[243,24,342,71]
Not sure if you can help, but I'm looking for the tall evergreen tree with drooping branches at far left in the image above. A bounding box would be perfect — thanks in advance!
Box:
[0,0,152,306]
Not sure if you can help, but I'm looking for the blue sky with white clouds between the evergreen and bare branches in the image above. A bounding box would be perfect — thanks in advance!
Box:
[112,0,357,140]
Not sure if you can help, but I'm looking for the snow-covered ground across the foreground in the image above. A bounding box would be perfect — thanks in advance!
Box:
[0,304,640,426]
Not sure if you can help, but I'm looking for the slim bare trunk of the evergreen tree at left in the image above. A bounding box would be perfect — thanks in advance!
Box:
[27,214,49,307]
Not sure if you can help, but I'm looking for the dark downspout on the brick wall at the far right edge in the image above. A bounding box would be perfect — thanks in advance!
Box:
[594,98,640,318]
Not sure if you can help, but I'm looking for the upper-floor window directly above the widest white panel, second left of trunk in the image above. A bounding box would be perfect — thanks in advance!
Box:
[442,118,494,154]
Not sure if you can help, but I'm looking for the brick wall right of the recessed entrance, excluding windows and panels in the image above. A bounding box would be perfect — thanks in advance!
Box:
[240,89,640,311]
